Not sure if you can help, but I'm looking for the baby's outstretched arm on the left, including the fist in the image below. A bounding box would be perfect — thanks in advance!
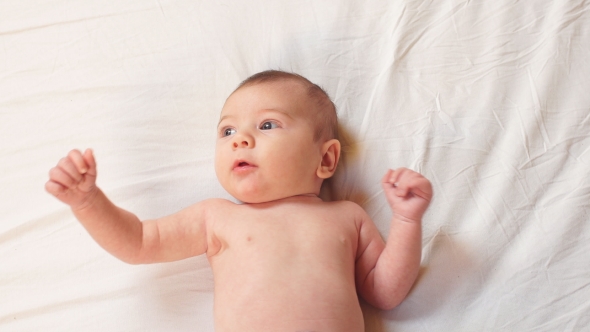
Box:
[45,150,208,264]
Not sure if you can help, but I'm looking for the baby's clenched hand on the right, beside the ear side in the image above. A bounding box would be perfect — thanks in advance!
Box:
[381,168,432,222]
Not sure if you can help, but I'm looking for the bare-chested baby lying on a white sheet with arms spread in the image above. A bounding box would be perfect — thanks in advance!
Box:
[46,71,432,332]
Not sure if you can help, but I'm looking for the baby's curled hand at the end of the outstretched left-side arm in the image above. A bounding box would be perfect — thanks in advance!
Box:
[45,149,97,210]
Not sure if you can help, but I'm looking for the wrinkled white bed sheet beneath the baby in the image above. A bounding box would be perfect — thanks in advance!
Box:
[0,0,590,332]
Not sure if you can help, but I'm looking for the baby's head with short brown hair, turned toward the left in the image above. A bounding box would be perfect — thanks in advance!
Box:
[215,71,340,203]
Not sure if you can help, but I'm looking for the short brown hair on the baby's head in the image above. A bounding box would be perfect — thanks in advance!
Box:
[234,70,338,142]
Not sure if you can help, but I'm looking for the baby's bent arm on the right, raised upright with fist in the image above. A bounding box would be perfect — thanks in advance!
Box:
[356,168,432,310]
